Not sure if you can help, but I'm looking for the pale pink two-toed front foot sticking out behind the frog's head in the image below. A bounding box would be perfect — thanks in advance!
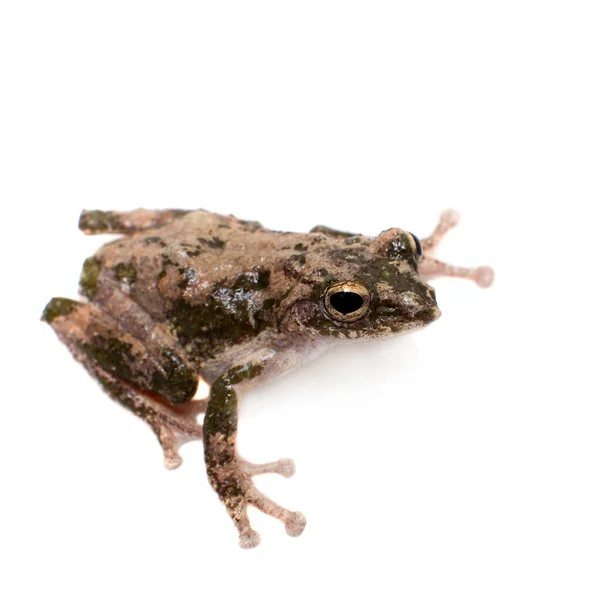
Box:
[419,210,494,288]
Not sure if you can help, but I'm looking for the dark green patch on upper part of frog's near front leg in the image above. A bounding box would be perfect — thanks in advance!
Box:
[204,363,263,440]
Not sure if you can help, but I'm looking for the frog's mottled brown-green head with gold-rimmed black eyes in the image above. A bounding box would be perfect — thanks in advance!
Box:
[284,229,440,339]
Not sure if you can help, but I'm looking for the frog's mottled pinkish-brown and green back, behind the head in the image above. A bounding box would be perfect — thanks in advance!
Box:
[81,211,292,363]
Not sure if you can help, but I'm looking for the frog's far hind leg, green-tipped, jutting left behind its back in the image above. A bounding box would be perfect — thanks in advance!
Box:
[79,208,190,235]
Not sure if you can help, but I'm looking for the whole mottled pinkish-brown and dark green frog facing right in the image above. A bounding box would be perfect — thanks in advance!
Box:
[42,209,494,548]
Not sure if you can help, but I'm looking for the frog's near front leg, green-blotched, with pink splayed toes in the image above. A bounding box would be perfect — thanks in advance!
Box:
[204,360,306,548]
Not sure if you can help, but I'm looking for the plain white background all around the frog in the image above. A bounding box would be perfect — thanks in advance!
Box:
[0,0,600,600]
